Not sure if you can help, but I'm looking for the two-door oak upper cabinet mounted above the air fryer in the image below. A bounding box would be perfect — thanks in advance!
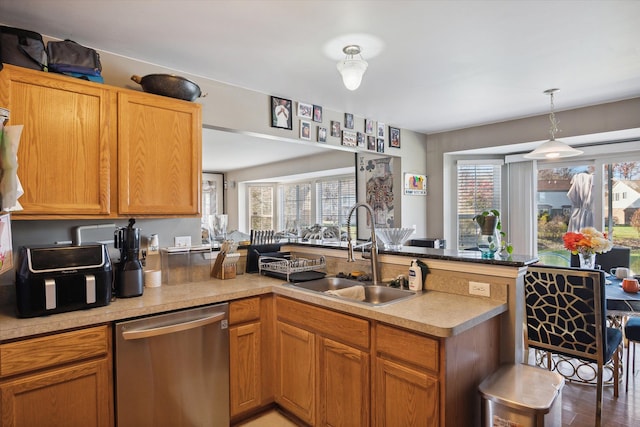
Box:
[0,65,202,219]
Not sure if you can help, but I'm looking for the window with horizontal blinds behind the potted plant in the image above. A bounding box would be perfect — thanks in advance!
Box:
[457,160,502,249]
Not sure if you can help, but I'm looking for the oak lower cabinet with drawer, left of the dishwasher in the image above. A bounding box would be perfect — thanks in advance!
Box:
[0,326,114,427]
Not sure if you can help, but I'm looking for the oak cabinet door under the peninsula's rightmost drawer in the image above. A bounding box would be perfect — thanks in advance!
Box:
[375,357,440,427]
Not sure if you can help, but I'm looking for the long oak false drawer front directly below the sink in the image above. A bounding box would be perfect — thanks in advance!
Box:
[277,297,370,350]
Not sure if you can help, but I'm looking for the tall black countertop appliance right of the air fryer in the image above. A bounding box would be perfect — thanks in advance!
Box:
[113,218,143,298]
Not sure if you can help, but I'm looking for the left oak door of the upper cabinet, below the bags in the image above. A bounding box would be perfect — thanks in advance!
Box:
[0,66,115,218]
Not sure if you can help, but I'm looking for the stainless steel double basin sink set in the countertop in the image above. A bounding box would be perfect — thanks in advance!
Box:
[287,277,417,306]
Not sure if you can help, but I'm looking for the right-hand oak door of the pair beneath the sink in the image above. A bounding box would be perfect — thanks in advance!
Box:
[318,338,370,427]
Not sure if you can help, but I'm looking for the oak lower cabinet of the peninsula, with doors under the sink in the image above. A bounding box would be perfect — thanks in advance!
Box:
[275,297,500,427]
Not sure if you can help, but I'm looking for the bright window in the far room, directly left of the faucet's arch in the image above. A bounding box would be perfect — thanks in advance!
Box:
[316,177,356,230]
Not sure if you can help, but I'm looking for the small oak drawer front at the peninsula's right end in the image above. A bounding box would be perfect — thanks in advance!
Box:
[376,324,440,372]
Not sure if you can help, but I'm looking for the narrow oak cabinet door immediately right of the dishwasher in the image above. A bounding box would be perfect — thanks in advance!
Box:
[229,322,262,417]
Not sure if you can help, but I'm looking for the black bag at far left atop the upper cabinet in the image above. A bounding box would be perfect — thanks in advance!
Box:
[0,25,47,71]
